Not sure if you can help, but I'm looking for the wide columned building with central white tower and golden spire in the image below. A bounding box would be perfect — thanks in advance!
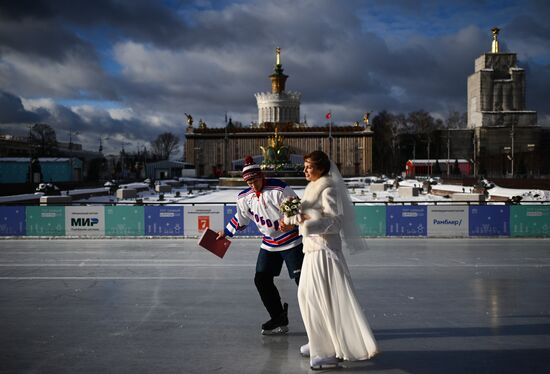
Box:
[184,48,372,177]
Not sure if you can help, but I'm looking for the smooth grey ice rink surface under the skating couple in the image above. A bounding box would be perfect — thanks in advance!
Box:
[0,239,550,374]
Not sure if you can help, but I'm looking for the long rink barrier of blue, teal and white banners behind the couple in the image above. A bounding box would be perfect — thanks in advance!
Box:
[0,204,550,238]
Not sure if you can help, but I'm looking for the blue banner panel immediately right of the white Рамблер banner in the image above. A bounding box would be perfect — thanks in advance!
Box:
[468,205,510,236]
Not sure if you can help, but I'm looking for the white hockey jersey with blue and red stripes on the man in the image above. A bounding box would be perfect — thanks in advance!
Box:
[224,178,302,252]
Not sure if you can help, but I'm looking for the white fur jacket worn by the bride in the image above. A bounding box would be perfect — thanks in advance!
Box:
[285,176,343,252]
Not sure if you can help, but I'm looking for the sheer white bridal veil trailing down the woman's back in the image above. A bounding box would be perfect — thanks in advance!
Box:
[329,160,368,254]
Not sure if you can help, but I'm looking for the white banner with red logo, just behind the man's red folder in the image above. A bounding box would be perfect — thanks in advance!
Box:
[183,205,224,236]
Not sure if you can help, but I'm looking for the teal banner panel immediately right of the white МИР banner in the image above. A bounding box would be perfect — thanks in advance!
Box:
[105,206,144,236]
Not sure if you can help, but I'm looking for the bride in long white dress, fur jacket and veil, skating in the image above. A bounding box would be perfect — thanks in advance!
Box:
[286,151,378,370]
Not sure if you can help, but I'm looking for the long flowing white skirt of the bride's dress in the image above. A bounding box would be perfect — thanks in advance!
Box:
[298,250,378,360]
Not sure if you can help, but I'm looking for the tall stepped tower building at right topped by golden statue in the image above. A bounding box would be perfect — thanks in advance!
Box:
[467,28,544,176]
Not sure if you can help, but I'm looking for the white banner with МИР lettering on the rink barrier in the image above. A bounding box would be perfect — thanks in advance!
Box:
[65,206,105,236]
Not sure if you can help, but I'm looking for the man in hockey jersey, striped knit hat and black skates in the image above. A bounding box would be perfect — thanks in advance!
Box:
[218,156,304,335]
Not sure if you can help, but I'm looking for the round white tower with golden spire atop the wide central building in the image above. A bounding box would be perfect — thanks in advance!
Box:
[254,48,301,124]
